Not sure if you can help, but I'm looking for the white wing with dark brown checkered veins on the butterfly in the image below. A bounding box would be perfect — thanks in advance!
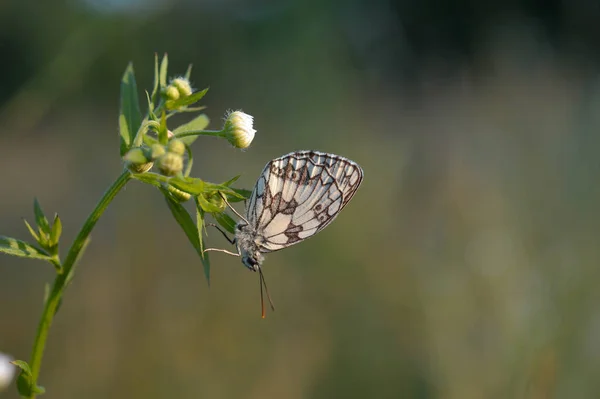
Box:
[246,151,363,253]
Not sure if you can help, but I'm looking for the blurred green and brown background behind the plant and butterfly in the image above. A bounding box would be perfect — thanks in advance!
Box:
[0,0,600,399]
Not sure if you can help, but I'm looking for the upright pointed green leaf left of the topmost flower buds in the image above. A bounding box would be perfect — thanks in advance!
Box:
[119,63,142,156]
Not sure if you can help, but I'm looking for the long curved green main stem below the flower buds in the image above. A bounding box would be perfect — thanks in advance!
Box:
[29,170,131,399]
